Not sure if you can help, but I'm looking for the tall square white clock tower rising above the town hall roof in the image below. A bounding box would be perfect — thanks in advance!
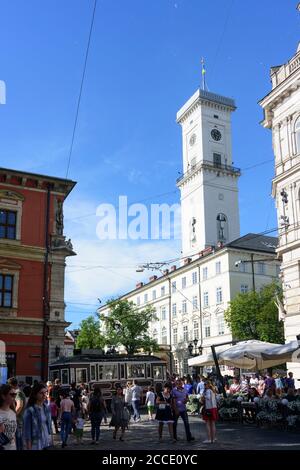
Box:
[177,89,240,256]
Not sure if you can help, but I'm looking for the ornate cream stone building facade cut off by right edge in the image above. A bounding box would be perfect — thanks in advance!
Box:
[260,42,300,384]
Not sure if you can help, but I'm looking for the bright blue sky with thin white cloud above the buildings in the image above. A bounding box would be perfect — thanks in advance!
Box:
[0,0,300,326]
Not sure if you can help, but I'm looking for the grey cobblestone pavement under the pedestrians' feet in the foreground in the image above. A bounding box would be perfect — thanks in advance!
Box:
[54,416,300,451]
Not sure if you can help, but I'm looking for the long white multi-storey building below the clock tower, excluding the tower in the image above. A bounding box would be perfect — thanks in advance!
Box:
[99,233,279,374]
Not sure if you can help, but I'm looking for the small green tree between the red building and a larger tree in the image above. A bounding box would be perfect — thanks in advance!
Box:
[76,315,105,349]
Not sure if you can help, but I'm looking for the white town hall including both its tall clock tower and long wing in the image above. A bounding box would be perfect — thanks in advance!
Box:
[99,86,279,374]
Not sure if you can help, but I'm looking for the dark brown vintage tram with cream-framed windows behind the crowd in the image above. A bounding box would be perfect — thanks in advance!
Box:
[49,350,167,401]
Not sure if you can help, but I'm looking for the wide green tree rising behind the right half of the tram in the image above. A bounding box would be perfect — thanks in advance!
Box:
[100,300,159,354]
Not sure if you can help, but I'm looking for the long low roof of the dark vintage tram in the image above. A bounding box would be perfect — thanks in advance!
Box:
[50,354,165,367]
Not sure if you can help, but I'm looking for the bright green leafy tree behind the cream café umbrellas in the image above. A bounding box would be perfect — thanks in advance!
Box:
[225,282,284,343]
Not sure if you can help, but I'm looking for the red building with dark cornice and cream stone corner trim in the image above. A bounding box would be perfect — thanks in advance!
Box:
[0,168,76,382]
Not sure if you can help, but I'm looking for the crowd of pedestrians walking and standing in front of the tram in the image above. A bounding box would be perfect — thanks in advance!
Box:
[0,377,217,450]
